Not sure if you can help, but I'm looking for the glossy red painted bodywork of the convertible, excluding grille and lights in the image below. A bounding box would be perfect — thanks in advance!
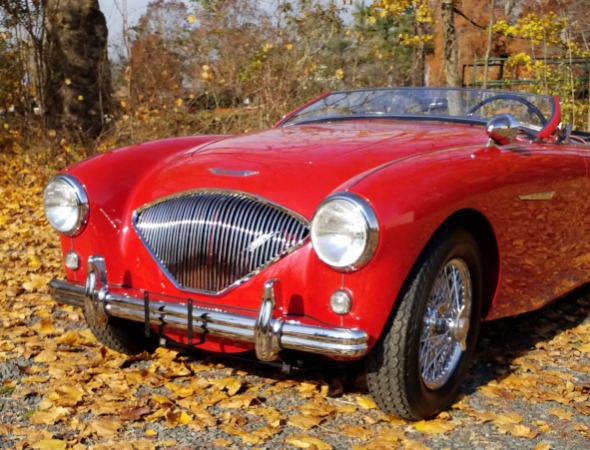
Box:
[62,120,590,351]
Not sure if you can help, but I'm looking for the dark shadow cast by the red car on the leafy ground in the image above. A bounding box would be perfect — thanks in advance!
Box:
[181,285,590,395]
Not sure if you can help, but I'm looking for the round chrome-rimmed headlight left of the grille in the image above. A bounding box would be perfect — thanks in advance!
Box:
[43,174,88,236]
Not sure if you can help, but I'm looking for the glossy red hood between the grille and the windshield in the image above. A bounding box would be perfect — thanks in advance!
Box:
[134,121,486,218]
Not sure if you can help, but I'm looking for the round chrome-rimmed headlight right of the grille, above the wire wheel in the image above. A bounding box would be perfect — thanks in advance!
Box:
[311,193,379,271]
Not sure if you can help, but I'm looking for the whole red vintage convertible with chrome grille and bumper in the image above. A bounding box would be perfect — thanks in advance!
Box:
[44,88,590,420]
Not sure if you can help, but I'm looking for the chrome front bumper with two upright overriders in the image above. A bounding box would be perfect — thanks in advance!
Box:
[50,255,368,361]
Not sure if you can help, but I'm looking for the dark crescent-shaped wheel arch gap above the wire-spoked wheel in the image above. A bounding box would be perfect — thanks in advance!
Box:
[434,209,500,318]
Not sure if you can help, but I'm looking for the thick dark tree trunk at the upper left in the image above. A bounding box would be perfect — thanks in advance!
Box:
[43,0,111,139]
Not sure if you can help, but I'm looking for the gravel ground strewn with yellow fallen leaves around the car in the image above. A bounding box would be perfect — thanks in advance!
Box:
[0,155,590,450]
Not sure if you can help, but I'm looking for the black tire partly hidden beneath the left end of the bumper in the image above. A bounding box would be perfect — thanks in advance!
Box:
[88,317,157,355]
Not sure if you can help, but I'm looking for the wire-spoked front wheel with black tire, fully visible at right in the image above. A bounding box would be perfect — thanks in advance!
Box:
[366,227,482,420]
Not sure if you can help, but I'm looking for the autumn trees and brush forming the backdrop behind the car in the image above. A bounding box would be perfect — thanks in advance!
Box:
[0,0,590,153]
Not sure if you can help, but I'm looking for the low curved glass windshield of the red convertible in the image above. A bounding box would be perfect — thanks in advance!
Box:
[279,88,559,136]
